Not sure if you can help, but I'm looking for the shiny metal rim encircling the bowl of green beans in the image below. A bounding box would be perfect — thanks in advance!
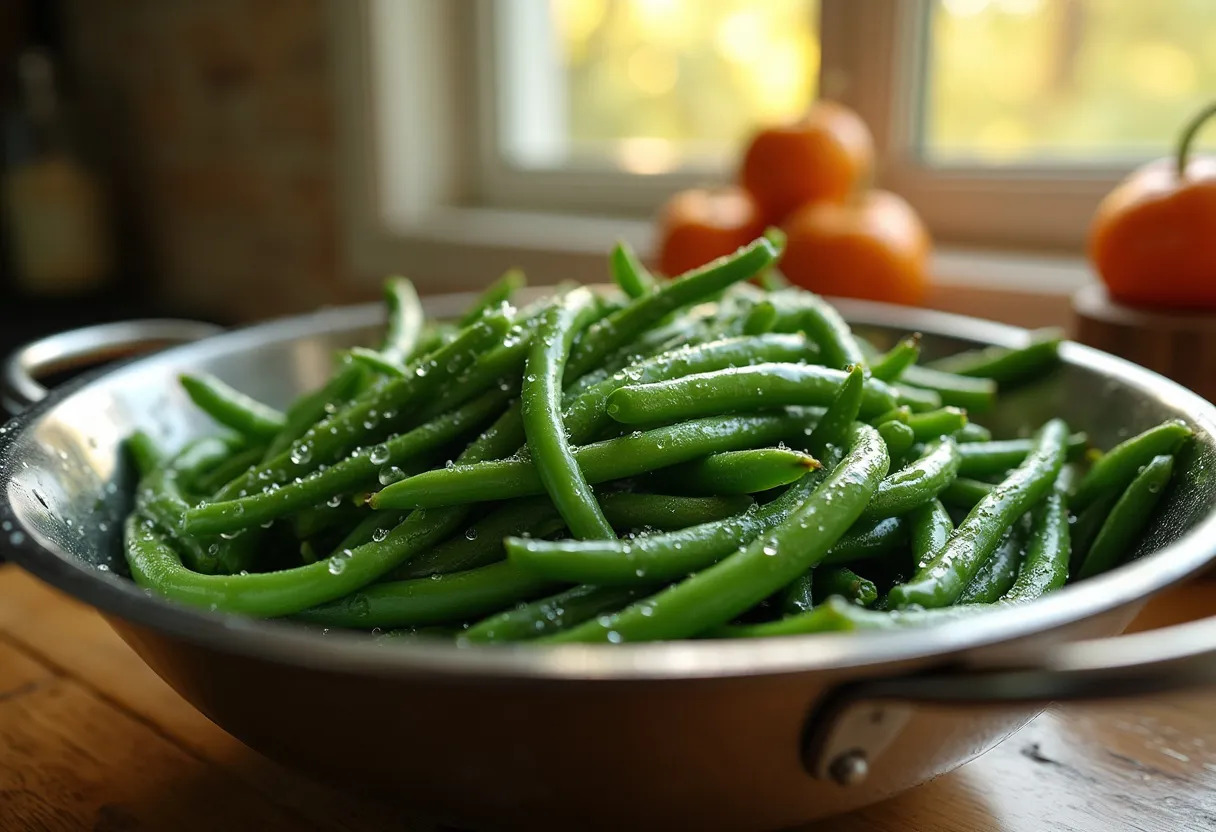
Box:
[0,296,1216,684]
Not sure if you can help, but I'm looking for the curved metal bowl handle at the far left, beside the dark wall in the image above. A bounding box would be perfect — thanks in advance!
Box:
[0,319,223,414]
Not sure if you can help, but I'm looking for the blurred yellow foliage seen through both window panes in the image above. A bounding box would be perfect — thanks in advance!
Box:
[537,0,1216,174]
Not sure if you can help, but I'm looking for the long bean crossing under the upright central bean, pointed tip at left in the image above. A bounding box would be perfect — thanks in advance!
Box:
[371,415,822,508]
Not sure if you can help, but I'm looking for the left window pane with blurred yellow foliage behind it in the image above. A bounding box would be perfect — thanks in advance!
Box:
[499,0,820,173]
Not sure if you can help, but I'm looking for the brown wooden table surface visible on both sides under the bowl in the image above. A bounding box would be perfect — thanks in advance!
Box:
[0,566,1216,832]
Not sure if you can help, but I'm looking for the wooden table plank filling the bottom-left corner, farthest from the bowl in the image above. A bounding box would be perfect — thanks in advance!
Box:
[0,641,317,830]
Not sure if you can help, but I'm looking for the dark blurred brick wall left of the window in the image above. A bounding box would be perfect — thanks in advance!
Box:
[64,0,351,319]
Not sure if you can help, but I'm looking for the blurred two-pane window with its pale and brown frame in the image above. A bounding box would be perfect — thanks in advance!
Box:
[331,0,1216,287]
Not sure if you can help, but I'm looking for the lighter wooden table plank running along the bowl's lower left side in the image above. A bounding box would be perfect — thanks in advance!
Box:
[0,566,409,830]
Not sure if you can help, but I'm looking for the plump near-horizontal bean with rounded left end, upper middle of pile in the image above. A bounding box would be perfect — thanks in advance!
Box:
[608,364,895,425]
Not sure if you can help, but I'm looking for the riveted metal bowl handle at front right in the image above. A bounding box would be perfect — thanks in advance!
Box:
[803,618,1216,786]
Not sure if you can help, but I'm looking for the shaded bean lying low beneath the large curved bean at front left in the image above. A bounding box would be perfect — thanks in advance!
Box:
[294,562,553,630]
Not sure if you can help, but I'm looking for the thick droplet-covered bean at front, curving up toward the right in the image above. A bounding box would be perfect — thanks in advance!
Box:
[544,423,888,642]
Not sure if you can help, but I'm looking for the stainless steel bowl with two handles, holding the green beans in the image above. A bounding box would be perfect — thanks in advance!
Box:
[0,297,1216,828]
